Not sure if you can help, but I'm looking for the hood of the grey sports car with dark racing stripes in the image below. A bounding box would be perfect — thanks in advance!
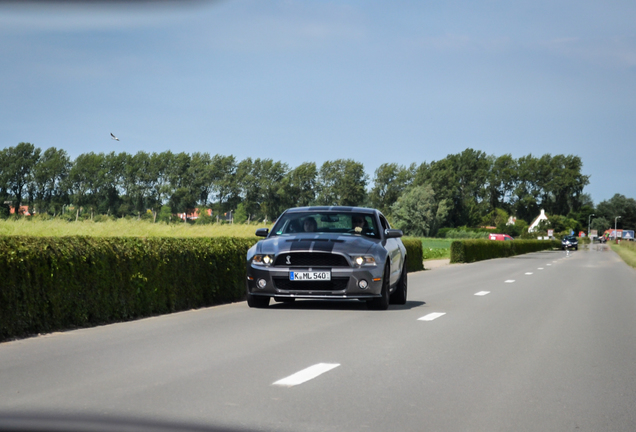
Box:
[254,234,380,255]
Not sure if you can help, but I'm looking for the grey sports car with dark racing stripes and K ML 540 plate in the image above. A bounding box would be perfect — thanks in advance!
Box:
[247,207,407,310]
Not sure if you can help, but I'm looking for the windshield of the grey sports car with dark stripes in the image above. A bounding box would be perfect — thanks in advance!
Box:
[272,212,380,238]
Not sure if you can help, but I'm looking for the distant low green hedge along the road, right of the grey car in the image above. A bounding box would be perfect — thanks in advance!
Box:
[451,240,561,263]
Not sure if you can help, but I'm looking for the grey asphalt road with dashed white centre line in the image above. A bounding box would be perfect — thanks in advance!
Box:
[0,246,636,432]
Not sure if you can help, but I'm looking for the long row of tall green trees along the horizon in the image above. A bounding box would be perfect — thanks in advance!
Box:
[0,143,633,235]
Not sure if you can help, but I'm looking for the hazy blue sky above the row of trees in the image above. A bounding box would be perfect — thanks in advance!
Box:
[0,0,636,204]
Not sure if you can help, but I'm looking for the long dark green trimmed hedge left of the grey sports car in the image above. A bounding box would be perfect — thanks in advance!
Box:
[0,237,257,340]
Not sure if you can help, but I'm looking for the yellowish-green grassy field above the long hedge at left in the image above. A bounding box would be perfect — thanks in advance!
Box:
[0,218,271,237]
